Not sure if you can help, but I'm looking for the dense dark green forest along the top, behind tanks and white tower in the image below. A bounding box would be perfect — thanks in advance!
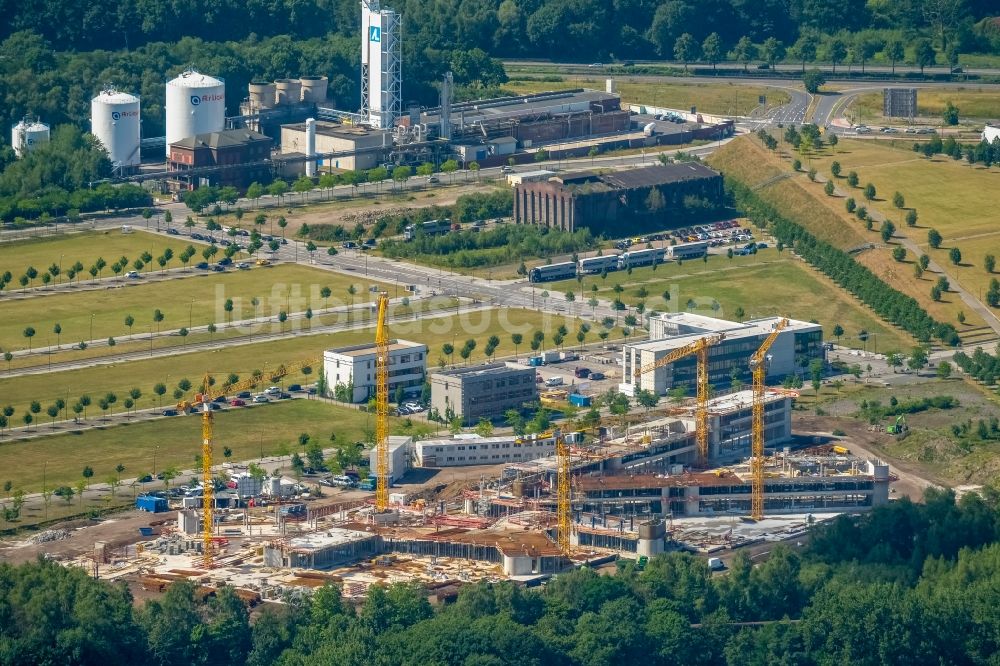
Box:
[0,0,1000,140]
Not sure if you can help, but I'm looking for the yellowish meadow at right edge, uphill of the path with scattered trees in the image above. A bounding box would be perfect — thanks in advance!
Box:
[813,138,1000,314]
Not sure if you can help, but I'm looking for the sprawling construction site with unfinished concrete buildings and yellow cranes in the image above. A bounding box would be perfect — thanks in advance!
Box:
[47,308,892,604]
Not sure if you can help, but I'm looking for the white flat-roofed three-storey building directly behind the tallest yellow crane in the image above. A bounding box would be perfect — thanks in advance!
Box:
[323,340,427,402]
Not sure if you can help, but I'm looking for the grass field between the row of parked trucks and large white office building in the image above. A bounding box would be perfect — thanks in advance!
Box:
[550,249,913,349]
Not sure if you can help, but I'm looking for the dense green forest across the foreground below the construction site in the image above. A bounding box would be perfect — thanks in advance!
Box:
[0,488,1000,666]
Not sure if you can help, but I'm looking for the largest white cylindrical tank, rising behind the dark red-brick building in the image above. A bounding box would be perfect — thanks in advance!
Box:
[167,69,226,157]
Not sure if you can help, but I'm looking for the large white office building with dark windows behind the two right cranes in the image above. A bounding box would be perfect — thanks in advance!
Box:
[619,312,824,395]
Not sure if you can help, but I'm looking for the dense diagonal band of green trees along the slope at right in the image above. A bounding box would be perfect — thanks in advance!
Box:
[726,179,959,346]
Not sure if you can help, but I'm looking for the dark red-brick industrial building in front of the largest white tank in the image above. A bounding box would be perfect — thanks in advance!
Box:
[167,129,272,191]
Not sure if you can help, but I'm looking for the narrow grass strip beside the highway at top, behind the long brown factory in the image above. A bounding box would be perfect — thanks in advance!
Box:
[503,75,789,115]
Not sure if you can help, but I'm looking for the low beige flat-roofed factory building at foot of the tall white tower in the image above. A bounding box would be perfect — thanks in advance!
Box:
[281,120,392,171]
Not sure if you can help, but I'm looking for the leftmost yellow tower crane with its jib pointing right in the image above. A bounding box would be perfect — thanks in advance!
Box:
[185,359,322,568]
